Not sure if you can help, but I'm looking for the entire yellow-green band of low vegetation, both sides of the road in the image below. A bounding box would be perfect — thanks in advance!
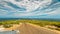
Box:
[0,19,60,31]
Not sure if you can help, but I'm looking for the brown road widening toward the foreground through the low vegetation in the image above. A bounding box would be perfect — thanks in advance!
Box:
[18,23,58,34]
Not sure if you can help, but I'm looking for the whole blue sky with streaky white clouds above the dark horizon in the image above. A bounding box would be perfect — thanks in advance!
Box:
[0,0,60,19]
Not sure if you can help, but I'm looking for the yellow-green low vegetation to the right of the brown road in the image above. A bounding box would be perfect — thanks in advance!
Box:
[20,20,60,31]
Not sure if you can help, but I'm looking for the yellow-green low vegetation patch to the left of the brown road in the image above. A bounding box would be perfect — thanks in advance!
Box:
[0,20,20,28]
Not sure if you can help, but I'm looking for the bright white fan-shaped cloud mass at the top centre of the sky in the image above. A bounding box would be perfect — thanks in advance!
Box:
[9,0,52,12]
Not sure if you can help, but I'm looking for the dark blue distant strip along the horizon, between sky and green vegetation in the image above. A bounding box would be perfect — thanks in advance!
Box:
[0,18,60,21]
